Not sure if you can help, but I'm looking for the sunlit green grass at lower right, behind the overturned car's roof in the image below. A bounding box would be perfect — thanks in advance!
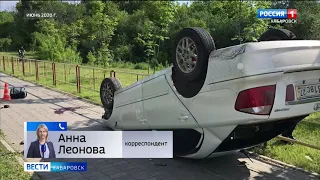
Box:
[254,113,320,174]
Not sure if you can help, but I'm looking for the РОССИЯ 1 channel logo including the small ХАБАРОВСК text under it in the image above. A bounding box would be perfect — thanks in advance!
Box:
[257,9,297,23]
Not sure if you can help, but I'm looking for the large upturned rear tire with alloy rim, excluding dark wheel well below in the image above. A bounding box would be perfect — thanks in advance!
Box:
[173,27,215,81]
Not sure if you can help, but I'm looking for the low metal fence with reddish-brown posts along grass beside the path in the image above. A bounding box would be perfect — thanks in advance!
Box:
[0,56,149,93]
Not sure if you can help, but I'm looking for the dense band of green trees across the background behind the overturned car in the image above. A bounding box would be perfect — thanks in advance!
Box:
[6,0,320,70]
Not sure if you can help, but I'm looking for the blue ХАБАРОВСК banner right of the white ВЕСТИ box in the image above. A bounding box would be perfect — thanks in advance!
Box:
[50,162,87,172]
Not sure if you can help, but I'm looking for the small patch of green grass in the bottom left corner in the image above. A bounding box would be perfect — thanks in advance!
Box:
[0,137,30,180]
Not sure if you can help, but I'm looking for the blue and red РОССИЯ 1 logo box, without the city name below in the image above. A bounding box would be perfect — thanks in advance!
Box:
[257,9,298,19]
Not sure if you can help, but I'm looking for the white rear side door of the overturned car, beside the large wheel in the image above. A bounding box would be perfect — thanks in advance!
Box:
[142,74,199,129]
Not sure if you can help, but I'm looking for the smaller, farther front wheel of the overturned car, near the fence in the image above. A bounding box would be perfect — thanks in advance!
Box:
[100,77,121,110]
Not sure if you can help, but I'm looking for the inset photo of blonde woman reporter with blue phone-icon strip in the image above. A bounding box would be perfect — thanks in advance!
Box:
[24,122,67,159]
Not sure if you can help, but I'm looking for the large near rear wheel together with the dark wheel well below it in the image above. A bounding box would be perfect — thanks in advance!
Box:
[172,27,216,98]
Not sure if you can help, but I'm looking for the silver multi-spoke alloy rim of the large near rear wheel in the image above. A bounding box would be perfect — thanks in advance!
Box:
[176,37,198,73]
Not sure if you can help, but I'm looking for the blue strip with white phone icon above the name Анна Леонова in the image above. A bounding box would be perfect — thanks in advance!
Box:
[26,122,68,131]
